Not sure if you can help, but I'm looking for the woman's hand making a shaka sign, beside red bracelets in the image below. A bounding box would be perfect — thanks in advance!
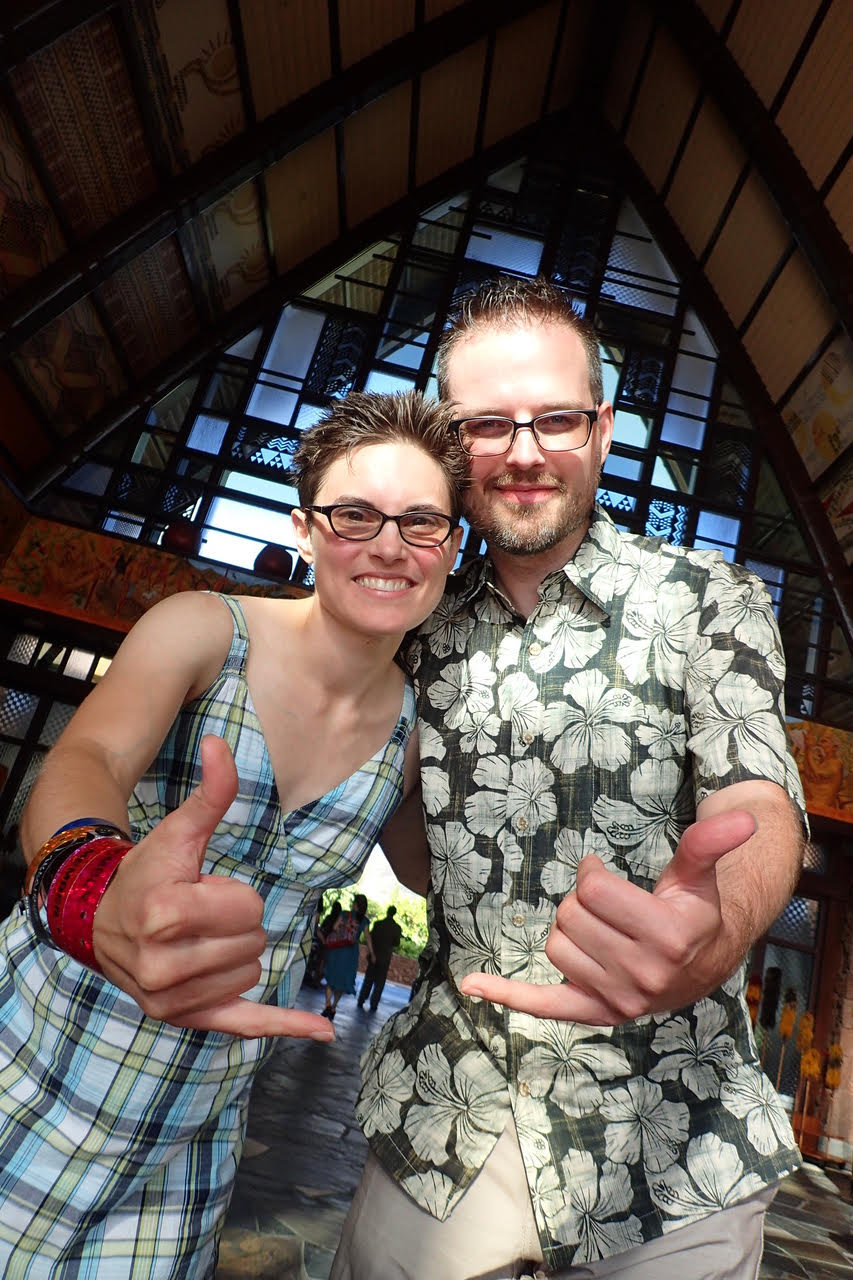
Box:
[93,737,334,1041]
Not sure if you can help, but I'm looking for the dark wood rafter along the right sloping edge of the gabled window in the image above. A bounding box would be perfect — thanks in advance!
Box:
[591,110,853,648]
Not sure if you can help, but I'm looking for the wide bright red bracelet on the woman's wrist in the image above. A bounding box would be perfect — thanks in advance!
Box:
[46,836,133,973]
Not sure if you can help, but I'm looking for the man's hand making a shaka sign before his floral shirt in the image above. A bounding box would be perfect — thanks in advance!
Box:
[461,809,756,1027]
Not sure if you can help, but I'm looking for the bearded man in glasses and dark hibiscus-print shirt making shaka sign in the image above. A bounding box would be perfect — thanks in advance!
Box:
[333,280,803,1280]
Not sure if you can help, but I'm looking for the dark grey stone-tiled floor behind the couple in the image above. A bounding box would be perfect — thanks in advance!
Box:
[216,983,853,1280]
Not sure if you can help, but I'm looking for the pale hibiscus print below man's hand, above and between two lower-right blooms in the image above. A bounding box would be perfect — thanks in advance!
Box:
[648,1000,740,1100]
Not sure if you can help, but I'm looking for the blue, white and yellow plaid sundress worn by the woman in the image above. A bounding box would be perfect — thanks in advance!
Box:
[0,596,415,1280]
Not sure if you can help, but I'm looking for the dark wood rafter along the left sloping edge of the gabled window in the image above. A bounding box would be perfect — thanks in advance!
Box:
[24,116,565,502]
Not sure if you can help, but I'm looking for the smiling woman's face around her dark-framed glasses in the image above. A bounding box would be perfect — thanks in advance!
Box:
[293,442,462,637]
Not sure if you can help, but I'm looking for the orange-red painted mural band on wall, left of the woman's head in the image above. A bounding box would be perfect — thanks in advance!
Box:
[0,517,306,631]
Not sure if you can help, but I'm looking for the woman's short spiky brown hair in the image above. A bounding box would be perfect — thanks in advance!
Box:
[291,392,467,517]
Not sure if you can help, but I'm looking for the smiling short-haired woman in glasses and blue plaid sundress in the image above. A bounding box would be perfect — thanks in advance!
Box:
[0,394,464,1280]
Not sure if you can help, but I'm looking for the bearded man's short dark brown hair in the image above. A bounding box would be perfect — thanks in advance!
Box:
[435,275,605,408]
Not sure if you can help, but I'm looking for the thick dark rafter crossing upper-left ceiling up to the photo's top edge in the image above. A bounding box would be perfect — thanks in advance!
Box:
[0,0,548,360]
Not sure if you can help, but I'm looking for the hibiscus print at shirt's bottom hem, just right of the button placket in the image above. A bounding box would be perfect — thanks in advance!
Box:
[553,1147,643,1266]
